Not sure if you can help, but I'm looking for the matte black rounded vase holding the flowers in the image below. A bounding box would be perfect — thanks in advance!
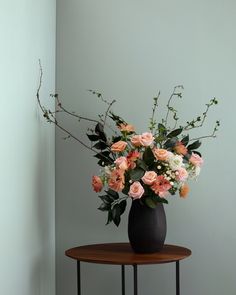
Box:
[128,200,166,253]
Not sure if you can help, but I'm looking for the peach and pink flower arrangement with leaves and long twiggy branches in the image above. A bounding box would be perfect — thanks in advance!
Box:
[37,67,220,226]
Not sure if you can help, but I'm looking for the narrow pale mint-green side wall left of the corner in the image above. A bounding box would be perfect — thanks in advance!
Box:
[0,0,56,295]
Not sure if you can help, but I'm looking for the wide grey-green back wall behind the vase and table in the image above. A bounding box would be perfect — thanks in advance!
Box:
[56,0,236,295]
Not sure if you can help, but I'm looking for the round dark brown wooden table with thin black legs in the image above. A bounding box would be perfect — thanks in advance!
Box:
[65,243,191,295]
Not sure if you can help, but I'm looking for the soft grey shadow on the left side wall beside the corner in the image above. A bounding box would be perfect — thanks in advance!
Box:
[30,118,55,295]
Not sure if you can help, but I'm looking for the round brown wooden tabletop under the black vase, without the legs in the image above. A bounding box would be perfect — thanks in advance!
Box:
[65,243,191,265]
